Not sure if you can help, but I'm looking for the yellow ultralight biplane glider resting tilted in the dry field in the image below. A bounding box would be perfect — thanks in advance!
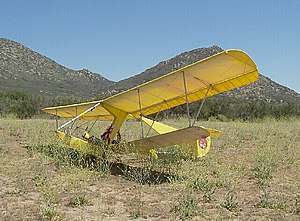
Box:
[43,50,259,157]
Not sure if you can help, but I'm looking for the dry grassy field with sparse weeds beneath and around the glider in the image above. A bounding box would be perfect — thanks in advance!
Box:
[0,116,300,220]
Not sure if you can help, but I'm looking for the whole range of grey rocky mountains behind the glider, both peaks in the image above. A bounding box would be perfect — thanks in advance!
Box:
[0,38,300,104]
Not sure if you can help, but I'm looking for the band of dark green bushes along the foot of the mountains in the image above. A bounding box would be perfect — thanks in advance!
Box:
[0,90,300,121]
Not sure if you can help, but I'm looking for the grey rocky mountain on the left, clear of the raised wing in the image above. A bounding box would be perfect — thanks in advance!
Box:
[0,38,112,97]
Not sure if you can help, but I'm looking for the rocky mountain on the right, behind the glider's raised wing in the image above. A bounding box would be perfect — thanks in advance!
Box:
[108,46,300,104]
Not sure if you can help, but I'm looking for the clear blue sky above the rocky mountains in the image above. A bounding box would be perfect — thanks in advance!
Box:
[0,0,300,93]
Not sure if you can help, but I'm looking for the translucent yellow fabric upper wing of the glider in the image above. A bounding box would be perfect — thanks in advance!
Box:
[43,50,258,120]
